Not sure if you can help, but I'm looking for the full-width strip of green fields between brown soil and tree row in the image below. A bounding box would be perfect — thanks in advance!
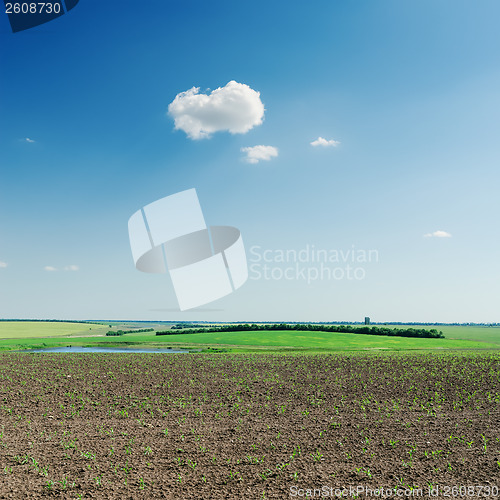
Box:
[0,321,500,352]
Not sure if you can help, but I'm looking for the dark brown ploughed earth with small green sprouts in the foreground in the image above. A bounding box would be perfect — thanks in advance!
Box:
[0,353,500,499]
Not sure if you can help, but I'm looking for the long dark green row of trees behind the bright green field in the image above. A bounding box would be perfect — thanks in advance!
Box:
[156,323,444,339]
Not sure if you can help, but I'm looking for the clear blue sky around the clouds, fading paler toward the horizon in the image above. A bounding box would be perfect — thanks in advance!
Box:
[0,0,500,322]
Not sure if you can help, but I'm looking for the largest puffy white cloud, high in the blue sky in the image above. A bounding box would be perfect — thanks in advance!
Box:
[168,80,264,139]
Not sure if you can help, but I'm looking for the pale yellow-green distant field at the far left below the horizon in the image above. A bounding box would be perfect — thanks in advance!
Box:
[0,321,103,339]
